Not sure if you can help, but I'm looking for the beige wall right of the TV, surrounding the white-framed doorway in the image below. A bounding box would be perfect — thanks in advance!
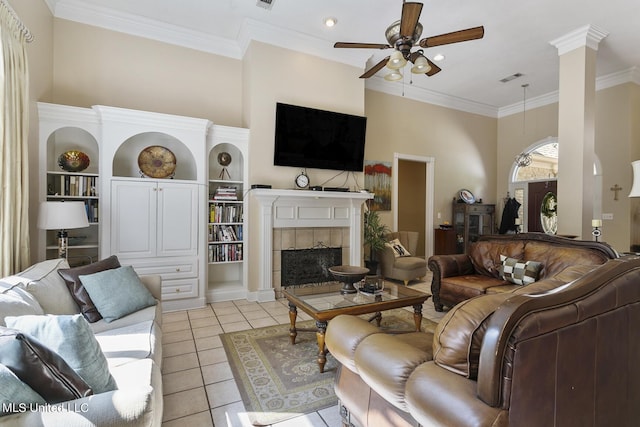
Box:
[365,90,497,229]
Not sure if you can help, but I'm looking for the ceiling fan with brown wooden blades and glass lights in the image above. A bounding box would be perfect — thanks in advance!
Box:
[333,2,484,80]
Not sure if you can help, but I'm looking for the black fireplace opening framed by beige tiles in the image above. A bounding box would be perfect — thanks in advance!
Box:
[280,247,342,287]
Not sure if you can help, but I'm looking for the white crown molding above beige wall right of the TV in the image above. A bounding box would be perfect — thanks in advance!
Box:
[365,76,498,118]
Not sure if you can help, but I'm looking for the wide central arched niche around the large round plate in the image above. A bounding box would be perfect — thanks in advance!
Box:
[112,132,196,181]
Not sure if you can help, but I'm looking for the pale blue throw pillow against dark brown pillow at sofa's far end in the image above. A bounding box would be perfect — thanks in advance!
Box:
[80,265,156,323]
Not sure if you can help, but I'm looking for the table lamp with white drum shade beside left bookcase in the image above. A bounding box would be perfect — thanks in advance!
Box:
[38,202,89,258]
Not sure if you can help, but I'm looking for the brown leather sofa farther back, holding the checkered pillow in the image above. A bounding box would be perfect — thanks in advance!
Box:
[428,233,617,311]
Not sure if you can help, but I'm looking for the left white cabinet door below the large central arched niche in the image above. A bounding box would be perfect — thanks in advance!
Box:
[111,180,158,258]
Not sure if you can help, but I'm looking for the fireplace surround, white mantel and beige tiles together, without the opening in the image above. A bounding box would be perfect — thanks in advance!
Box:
[252,189,373,301]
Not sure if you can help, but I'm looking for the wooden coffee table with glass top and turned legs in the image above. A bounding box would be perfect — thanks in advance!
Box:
[283,282,431,372]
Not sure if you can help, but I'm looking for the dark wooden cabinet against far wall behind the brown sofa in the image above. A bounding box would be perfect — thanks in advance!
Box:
[452,200,496,253]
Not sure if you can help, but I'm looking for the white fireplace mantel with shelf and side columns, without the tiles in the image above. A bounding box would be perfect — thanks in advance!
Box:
[251,189,373,301]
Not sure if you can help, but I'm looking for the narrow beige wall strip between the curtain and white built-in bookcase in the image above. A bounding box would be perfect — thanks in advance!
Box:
[9,0,53,262]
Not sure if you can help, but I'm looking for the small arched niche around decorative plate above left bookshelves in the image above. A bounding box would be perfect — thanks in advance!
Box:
[46,126,100,174]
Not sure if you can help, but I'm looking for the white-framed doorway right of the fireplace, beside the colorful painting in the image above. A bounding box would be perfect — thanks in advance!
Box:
[392,153,434,257]
